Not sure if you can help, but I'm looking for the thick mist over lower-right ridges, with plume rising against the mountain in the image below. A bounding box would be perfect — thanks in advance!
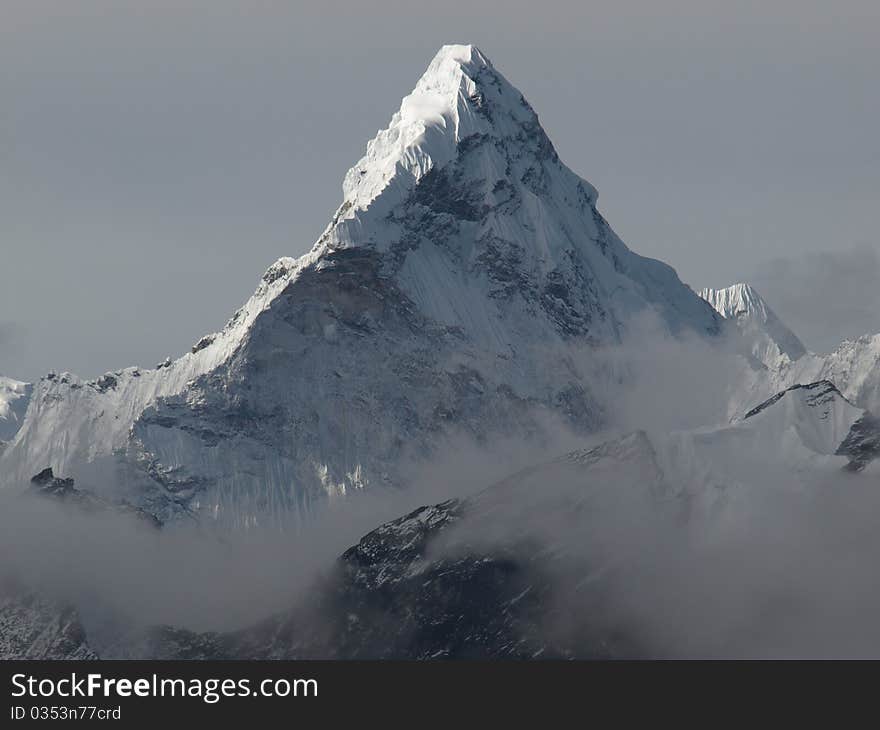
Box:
[424,322,880,659]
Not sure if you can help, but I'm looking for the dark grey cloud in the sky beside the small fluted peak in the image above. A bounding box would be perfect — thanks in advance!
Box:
[751,246,880,352]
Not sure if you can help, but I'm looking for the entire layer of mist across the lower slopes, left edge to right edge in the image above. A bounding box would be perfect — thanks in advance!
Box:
[0,316,880,658]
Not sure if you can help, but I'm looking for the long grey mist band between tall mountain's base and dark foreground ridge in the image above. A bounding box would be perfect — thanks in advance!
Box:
[0,416,583,641]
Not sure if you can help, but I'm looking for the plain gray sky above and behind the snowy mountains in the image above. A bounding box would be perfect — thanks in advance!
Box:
[0,0,880,379]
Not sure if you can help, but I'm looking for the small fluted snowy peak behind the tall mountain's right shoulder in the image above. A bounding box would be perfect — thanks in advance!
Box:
[700,284,807,366]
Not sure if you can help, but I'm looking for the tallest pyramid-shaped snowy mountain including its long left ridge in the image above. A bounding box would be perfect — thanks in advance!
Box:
[0,46,720,527]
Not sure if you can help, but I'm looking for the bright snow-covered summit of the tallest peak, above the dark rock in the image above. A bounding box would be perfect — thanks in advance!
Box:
[317,45,597,255]
